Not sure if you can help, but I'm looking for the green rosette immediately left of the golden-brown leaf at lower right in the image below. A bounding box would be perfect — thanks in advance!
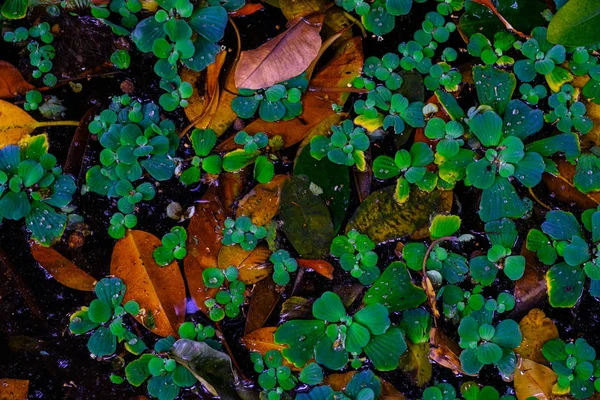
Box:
[458,309,522,376]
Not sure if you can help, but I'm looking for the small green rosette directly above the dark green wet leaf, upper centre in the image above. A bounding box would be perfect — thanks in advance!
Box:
[310,120,370,171]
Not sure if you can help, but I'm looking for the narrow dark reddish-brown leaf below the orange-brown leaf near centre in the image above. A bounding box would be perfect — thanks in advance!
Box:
[244,277,281,333]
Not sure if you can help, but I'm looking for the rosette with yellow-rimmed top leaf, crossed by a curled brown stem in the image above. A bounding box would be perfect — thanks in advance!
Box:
[402,215,469,286]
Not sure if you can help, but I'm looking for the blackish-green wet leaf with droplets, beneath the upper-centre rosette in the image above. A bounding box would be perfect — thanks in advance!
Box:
[294,146,350,232]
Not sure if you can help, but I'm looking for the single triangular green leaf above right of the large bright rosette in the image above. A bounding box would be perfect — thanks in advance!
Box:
[363,261,427,312]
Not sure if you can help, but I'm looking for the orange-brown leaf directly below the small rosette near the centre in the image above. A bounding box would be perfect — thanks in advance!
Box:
[218,245,272,285]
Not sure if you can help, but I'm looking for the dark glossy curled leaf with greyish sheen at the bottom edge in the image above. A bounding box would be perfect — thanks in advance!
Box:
[170,339,243,400]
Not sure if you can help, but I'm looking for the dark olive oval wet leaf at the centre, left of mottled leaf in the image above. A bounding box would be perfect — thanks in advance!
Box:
[279,176,334,258]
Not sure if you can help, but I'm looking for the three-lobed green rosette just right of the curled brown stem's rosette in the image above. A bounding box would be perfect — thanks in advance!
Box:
[469,219,525,286]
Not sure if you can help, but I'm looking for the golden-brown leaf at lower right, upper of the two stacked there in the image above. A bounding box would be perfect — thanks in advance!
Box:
[515,308,558,365]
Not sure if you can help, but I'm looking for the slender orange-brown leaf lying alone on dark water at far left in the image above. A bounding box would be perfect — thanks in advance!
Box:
[30,242,96,292]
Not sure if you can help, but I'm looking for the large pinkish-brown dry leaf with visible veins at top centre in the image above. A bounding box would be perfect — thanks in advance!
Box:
[235,14,324,90]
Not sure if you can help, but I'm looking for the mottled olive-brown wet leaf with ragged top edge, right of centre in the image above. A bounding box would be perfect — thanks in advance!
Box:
[346,186,452,243]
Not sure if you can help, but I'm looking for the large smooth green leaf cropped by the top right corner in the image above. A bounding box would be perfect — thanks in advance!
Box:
[548,0,600,47]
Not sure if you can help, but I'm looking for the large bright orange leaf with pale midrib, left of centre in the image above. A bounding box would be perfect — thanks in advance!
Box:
[110,230,185,336]
